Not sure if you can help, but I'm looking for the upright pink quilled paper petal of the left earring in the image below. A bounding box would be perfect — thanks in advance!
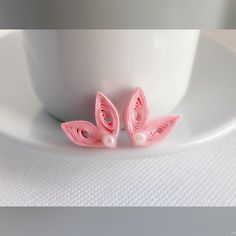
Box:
[95,92,120,137]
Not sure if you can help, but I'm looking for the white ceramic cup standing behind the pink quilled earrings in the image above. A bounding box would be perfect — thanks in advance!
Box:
[24,30,199,121]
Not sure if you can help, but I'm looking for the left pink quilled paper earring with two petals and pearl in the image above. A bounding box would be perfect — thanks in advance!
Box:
[61,92,120,148]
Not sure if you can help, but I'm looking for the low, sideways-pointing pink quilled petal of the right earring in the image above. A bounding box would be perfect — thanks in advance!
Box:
[145,115,179,145]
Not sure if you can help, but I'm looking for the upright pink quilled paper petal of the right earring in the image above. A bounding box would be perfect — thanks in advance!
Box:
[124,88,149,136]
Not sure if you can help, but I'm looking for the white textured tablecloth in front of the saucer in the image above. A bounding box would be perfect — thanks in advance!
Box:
[0,129,236,206]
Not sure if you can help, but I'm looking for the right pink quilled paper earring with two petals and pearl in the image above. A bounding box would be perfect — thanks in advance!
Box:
[124,88,179,146]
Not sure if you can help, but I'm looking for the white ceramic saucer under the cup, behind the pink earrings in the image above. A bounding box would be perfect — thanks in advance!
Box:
[0,32,236,159]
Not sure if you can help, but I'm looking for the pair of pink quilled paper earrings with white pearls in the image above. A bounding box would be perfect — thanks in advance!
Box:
[61,88,179,148]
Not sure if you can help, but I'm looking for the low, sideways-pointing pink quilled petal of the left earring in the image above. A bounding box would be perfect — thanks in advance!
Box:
[61,121,103,147]
